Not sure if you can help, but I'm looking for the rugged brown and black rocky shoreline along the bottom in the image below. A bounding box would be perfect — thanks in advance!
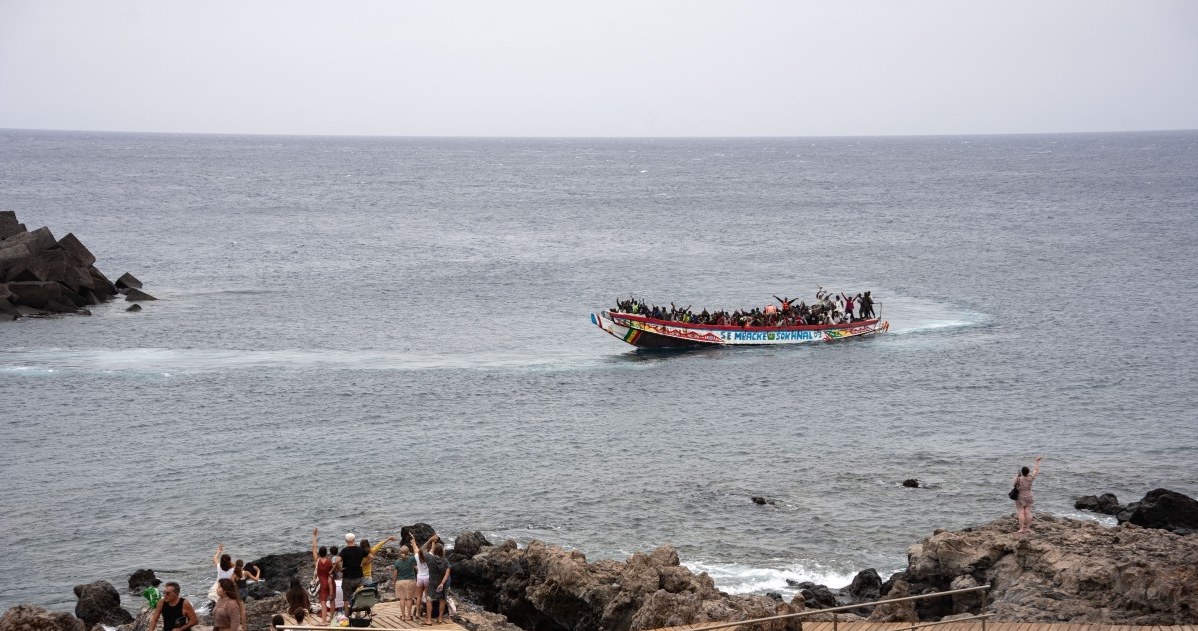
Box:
[0,490,1198,631]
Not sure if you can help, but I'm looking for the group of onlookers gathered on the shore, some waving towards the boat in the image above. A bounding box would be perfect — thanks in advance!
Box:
[143,528,450,631]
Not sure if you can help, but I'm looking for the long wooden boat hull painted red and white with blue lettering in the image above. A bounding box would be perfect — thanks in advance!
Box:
[591,311,890,348]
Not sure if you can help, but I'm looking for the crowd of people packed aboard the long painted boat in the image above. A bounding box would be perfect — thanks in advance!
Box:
[615,287,875,327]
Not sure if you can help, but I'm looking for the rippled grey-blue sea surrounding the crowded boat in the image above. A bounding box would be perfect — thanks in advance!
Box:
[0,131,1198,609]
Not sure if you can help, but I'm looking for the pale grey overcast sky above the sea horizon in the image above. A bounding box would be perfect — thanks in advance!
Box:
[0,0,1198,136]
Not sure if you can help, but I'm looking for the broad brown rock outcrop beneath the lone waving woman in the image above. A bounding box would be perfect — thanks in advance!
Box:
[888,514,1198,625]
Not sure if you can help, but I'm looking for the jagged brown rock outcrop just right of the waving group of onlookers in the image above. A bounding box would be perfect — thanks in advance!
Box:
[454,540,803,631]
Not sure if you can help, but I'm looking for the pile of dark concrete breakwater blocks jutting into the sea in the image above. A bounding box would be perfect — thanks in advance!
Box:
[0,211,145,321]
